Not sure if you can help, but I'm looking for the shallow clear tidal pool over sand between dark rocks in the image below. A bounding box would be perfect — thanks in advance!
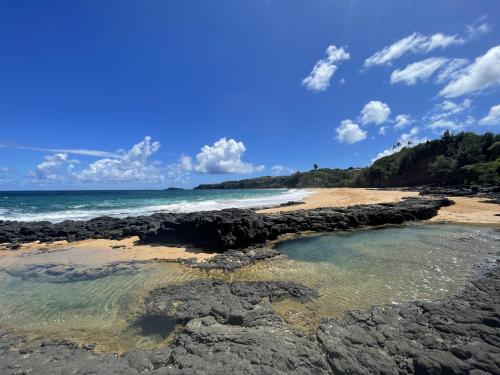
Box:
[0,224,500,352]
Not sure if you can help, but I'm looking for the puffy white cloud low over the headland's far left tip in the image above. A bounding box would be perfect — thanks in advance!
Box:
[190,138,264,174]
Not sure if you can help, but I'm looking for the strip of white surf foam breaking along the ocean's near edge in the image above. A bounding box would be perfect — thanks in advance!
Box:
[0,189,311,223]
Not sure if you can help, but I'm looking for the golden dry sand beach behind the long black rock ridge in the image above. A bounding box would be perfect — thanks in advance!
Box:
[259,188,500,224]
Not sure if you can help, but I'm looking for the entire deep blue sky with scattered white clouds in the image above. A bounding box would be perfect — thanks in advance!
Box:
[0,0,500,190]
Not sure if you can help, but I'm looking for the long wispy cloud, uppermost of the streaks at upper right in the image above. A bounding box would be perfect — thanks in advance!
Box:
[364,33,465,68]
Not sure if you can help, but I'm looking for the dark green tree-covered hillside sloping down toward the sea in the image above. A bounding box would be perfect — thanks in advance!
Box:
[197,132,500,189]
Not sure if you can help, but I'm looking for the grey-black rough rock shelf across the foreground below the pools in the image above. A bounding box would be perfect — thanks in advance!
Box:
[0,262,500,375]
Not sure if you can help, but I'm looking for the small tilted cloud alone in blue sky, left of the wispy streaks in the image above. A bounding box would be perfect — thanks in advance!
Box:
[302,45,350,92]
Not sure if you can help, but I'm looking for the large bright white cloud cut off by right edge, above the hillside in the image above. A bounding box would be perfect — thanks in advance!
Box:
[439,45,500,98]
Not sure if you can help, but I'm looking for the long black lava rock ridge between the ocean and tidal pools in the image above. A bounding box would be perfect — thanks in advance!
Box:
[0,198,453,251]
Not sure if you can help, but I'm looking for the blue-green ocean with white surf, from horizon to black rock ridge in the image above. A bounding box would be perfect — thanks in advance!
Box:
[0,189,309,223]
